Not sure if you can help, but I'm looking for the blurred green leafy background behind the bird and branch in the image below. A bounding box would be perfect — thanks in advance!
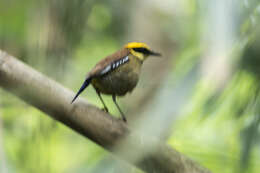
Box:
[0,0,260,173]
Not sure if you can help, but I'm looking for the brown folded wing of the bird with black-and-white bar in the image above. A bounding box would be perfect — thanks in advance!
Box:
[87,48,130,76]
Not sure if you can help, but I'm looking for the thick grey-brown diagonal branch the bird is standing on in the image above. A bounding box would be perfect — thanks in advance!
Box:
[0,50,210,173]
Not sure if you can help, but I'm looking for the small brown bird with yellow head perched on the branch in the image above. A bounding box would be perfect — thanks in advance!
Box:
[71,42,161,122]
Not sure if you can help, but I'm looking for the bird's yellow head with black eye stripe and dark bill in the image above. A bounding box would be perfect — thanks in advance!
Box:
[124,42,161,61]
